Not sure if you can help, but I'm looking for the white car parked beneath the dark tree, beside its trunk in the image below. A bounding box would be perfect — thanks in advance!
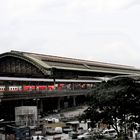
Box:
[102,129,117,138]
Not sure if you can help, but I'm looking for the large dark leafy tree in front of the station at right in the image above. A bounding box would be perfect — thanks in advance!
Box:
[81,77,140,138]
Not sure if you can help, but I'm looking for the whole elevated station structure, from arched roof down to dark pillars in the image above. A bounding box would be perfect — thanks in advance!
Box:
[0,51,140,118]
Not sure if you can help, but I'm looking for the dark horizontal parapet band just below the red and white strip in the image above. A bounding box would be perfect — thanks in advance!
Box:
[0,89,91,100]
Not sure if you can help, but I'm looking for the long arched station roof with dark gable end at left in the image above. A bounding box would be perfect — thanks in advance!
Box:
[0,51,140,79]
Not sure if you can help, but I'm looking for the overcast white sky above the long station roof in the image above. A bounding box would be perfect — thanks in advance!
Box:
[0,0,140,68]
